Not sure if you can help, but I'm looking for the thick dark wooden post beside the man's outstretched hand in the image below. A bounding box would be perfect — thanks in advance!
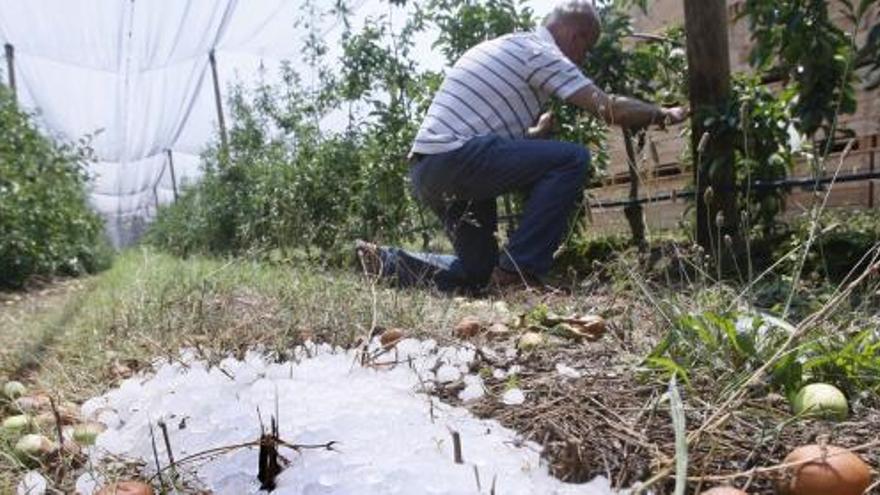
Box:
[684,0,740,255]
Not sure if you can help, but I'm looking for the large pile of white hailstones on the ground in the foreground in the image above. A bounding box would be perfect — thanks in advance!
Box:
[77,340,611,495]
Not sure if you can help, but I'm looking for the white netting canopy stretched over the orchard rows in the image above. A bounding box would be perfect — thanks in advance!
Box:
[0,0,549,246]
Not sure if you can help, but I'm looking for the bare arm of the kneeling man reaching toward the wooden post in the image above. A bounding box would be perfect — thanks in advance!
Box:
[567,84,687,129]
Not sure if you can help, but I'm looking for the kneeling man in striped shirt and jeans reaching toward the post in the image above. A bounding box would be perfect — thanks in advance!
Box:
[356,0,687,292]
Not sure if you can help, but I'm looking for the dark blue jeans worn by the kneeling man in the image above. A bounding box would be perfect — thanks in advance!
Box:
[380,136,590,291]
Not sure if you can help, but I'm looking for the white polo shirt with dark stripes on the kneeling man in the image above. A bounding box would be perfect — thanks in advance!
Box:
[412,27,592,155]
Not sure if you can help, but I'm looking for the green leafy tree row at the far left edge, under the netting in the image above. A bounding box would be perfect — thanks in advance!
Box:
[0,86,109,287]
